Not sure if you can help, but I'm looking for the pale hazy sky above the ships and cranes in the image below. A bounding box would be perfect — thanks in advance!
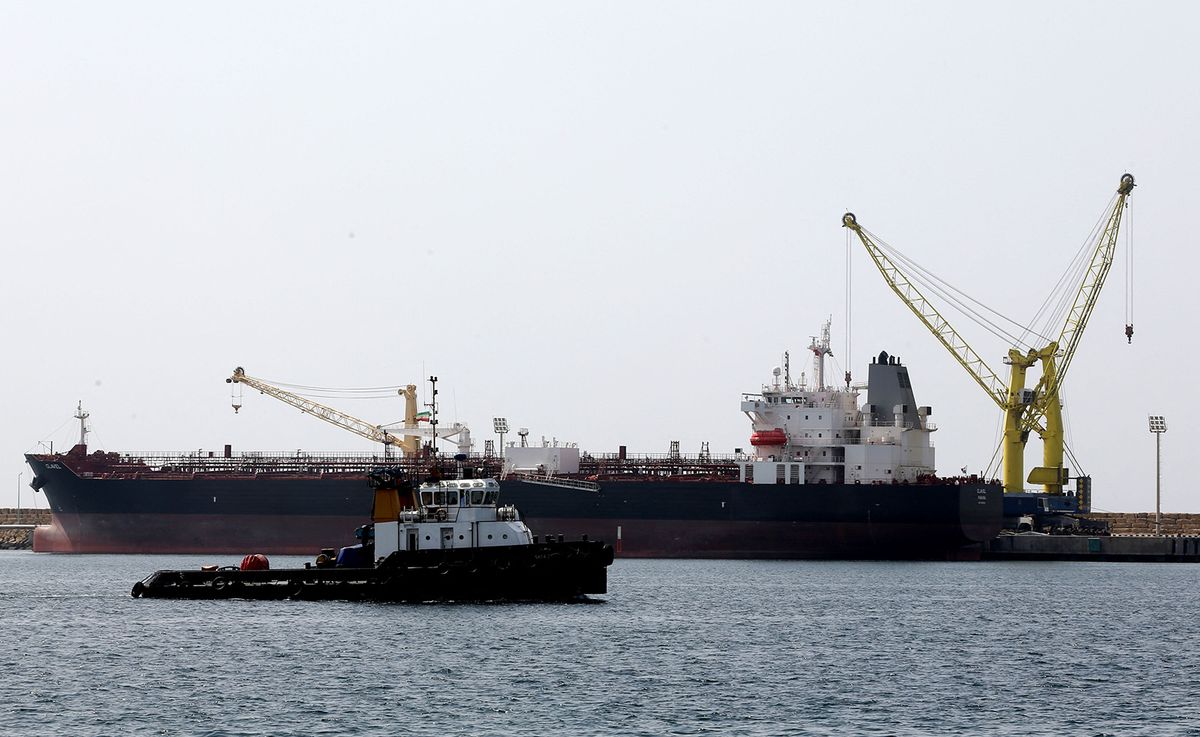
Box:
[0,2,1200,511]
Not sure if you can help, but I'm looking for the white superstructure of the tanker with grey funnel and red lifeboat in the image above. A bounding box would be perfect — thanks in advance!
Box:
[739,322,936,484]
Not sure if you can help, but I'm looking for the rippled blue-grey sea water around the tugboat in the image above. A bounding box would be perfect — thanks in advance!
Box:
[0,552,1200,737]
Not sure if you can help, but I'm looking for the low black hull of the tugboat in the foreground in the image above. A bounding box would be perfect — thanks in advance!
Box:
[131,541,613,601]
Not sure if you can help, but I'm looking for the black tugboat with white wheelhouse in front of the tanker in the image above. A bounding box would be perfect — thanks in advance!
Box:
[131,468,613,601]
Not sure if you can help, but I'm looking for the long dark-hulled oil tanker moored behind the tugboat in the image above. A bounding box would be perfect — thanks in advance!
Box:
[25,323,1003,559]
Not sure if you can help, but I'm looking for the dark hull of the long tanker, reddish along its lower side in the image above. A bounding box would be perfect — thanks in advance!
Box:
[28,456,1003,559]
